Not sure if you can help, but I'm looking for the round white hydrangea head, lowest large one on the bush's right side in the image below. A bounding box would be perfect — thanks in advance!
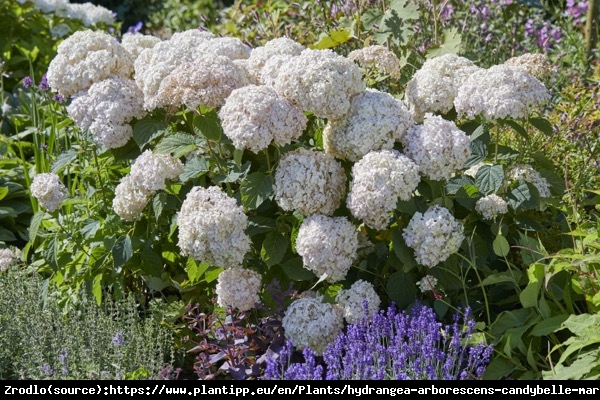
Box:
[402,205,465,267]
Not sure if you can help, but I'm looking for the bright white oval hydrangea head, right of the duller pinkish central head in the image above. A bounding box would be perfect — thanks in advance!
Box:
[346,149,421,230]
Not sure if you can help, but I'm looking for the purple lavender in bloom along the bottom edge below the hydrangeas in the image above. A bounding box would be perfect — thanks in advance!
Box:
[263,304,493,380]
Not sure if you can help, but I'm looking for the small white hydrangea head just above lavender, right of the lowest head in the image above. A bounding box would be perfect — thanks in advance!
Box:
[335,279,381,324]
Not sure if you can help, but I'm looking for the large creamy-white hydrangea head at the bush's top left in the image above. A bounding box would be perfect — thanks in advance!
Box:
[46,30,133,97]
